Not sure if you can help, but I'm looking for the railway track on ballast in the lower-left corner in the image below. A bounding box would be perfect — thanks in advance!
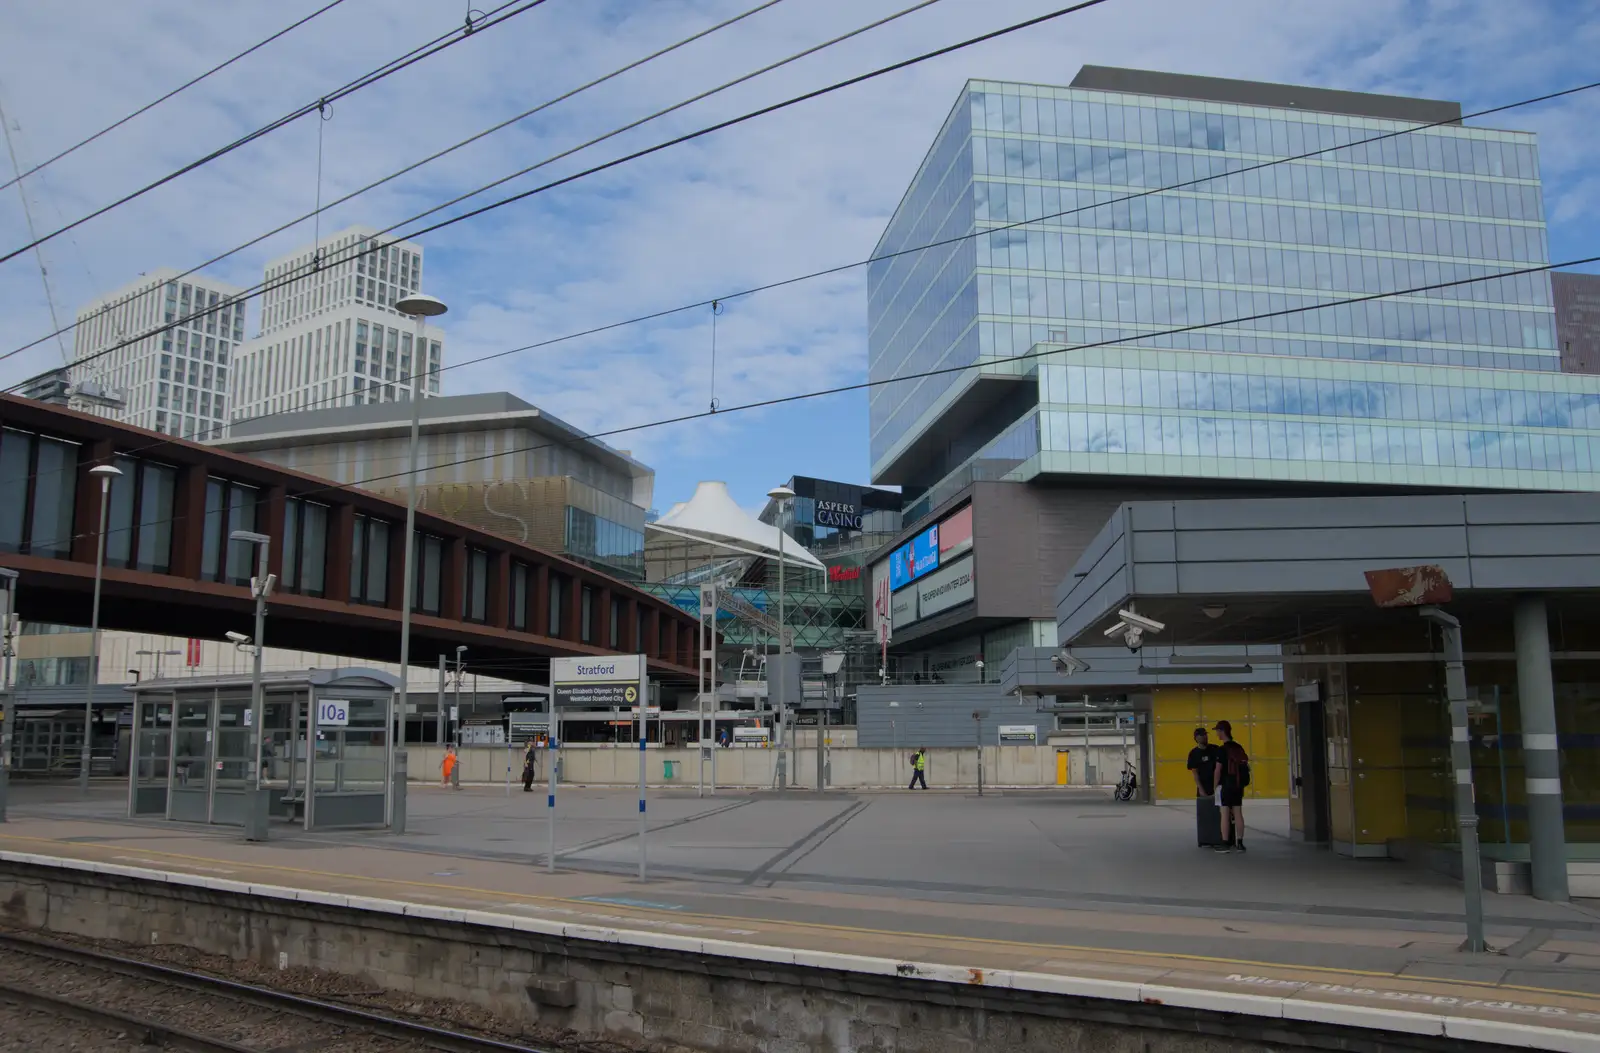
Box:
[0,931,550,1053]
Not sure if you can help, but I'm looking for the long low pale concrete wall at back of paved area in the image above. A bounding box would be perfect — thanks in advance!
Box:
[406,739,1109,789]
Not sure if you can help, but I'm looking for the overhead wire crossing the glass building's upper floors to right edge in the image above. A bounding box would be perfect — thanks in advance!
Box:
[9,69,1600,470]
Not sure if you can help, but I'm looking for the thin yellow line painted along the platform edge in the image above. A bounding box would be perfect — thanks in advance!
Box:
[0,834,1600,999]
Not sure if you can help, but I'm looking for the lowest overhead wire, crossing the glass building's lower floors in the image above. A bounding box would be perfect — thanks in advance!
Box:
[6,254,1600,549]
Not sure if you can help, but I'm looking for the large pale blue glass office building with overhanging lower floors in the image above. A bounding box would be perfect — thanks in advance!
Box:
[867,67,1600,505]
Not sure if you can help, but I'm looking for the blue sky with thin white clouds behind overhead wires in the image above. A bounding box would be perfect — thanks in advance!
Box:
[0,0,1600,510]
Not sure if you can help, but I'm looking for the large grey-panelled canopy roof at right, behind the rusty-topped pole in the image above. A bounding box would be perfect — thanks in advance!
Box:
[1056,493,1600,647]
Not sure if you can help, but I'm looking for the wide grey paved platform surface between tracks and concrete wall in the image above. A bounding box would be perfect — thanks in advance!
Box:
[9,786,1600,1034]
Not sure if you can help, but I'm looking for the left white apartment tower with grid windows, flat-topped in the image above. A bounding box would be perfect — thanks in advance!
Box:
[70,267,245,438]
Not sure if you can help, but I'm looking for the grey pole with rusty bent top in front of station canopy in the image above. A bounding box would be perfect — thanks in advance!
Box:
[1366,563,1486,954]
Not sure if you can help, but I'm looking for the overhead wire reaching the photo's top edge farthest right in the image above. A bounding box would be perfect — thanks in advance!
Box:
[9,0,1107,390]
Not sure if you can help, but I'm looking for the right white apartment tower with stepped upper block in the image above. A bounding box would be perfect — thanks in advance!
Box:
[230,227,443,421]
